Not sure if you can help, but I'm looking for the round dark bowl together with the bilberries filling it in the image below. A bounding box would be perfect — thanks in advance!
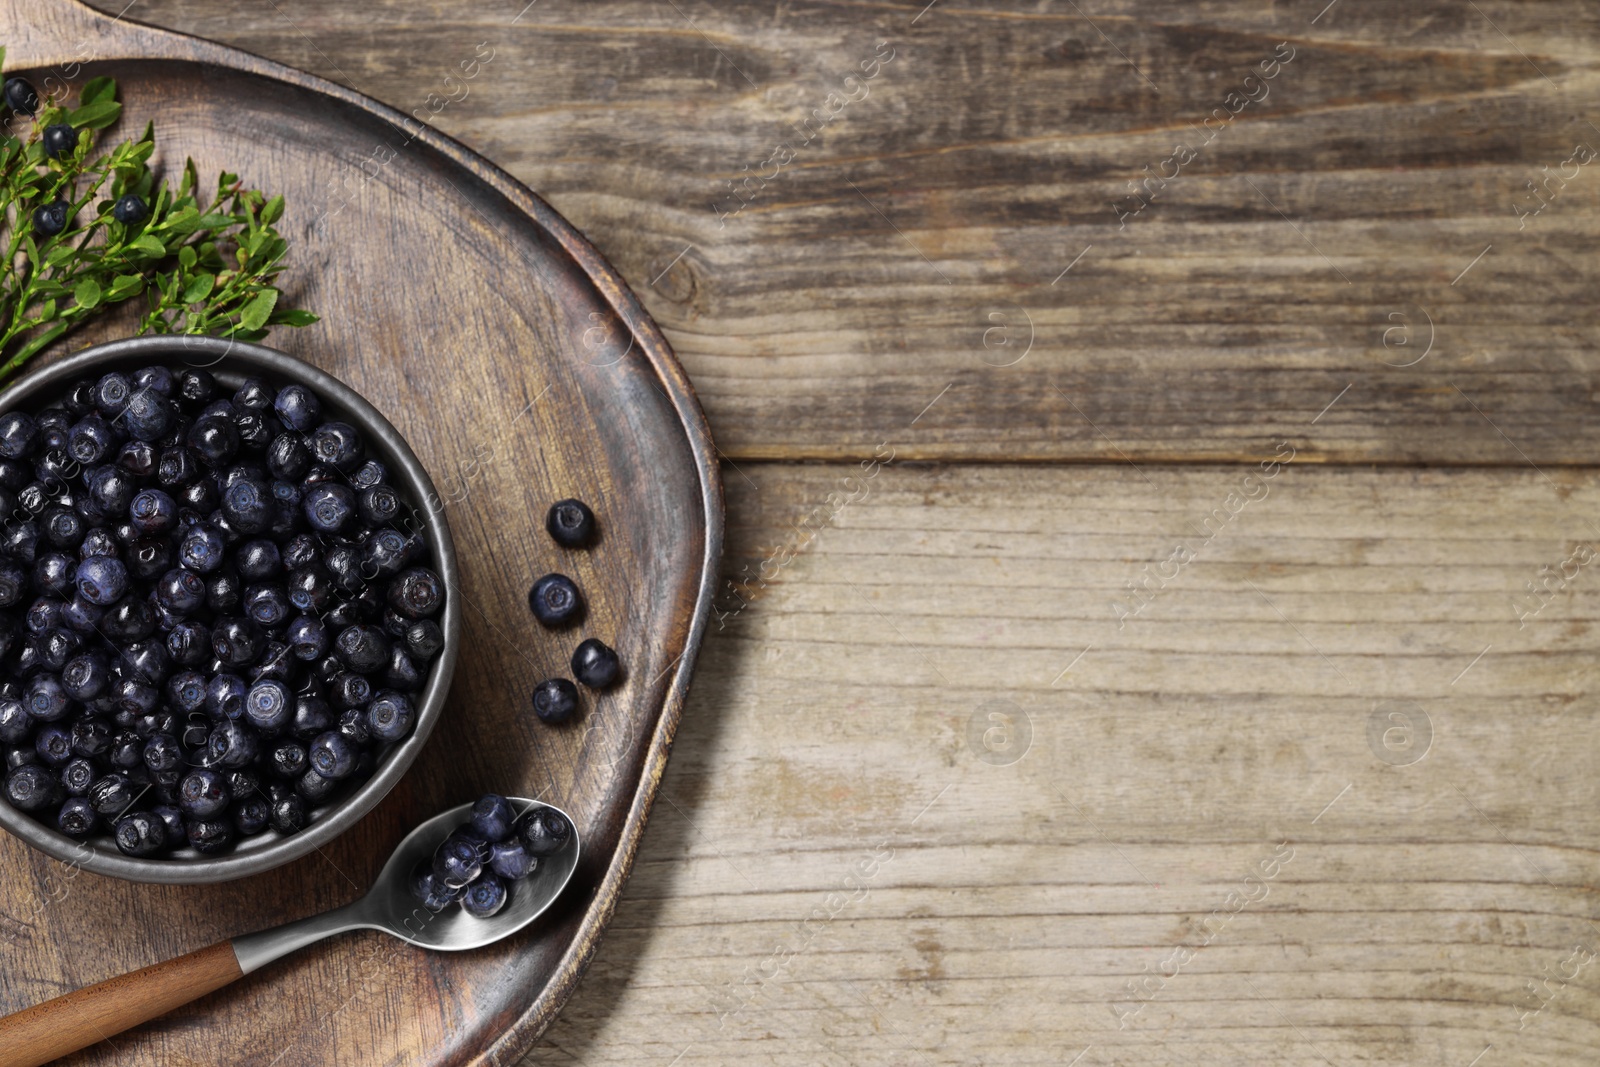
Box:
[0,339,458,881]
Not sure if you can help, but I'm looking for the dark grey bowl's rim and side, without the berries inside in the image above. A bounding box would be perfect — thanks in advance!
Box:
[0,336,461,883]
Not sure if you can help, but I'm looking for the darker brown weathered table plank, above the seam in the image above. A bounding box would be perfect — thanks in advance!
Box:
[84,0,1600,466]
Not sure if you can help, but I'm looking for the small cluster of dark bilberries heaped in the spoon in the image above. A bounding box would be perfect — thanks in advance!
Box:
[411,793,573,918]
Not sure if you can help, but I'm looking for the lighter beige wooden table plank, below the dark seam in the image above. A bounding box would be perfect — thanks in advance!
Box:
[525,459,1600,1067]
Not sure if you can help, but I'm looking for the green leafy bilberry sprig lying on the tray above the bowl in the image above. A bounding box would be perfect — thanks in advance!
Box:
[0,48,317,381]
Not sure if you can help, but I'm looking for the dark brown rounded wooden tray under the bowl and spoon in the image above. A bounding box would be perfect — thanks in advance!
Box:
[0,0,722,1067]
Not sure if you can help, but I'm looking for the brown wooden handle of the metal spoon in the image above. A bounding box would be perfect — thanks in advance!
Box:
[0,941,243,1067]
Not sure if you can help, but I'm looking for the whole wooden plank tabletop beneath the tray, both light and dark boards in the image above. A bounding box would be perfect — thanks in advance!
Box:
[84,0,1600,1067]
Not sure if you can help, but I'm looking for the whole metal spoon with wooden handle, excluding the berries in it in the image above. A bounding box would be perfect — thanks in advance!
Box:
[0,797,579,1067]
